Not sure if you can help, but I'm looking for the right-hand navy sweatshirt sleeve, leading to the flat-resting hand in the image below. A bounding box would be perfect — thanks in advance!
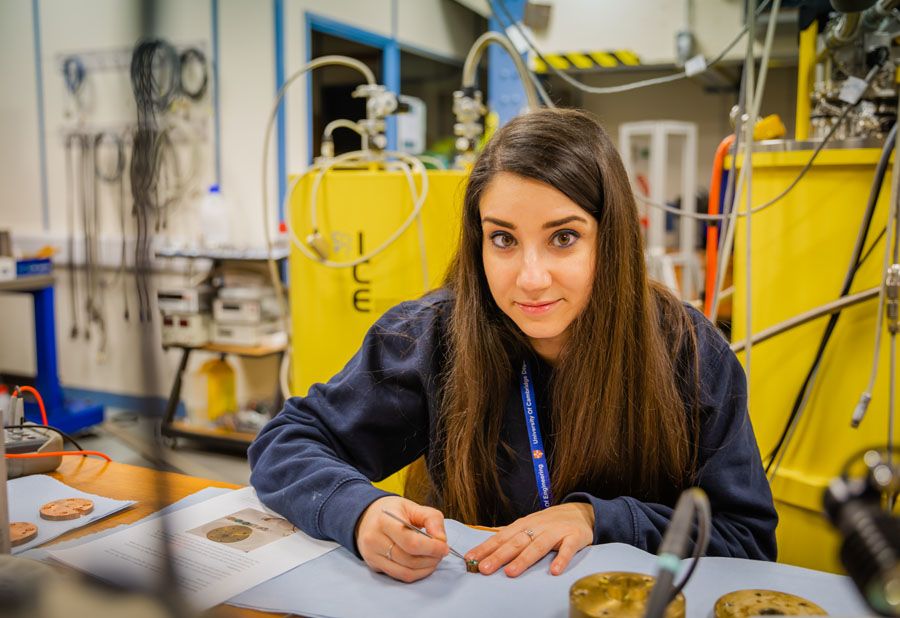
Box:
[563,325,778,560]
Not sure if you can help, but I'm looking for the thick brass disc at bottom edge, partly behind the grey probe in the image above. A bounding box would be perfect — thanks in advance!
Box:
[569,572,686,618]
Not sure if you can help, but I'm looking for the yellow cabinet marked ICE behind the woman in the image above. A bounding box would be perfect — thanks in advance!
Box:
[289,169,468,493]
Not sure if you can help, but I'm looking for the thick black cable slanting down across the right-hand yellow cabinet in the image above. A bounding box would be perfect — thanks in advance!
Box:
[766,122,897,474]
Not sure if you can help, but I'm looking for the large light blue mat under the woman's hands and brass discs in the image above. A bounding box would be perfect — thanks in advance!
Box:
[229,521,868,618]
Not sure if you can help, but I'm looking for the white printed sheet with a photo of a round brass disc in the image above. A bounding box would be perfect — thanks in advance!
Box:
[49,487,337,610]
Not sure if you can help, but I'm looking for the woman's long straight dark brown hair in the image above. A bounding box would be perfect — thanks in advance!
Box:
[429,109,699,523]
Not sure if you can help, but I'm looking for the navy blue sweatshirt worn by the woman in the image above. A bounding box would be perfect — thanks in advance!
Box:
[249,291,778,560]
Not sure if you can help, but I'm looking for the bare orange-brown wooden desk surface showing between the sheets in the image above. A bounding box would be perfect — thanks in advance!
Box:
[48,457,285,618]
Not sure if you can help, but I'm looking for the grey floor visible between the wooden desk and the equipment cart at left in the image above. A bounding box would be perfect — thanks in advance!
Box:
[76,408,250,485]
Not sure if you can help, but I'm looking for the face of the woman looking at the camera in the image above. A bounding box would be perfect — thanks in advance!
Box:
[479,172,597,362]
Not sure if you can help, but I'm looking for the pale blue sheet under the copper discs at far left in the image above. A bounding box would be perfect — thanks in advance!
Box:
[7,474,135,554]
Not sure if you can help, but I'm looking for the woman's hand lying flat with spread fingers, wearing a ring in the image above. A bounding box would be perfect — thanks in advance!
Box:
[466,502,594,577]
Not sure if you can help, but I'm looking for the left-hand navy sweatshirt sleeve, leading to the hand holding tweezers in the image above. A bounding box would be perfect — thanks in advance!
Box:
[248,301,435,555]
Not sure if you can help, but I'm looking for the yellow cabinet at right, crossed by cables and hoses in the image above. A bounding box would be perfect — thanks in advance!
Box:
[733,143,891,572]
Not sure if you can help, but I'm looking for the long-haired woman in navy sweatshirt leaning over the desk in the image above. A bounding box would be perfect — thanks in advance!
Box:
[250,110,777,581]
